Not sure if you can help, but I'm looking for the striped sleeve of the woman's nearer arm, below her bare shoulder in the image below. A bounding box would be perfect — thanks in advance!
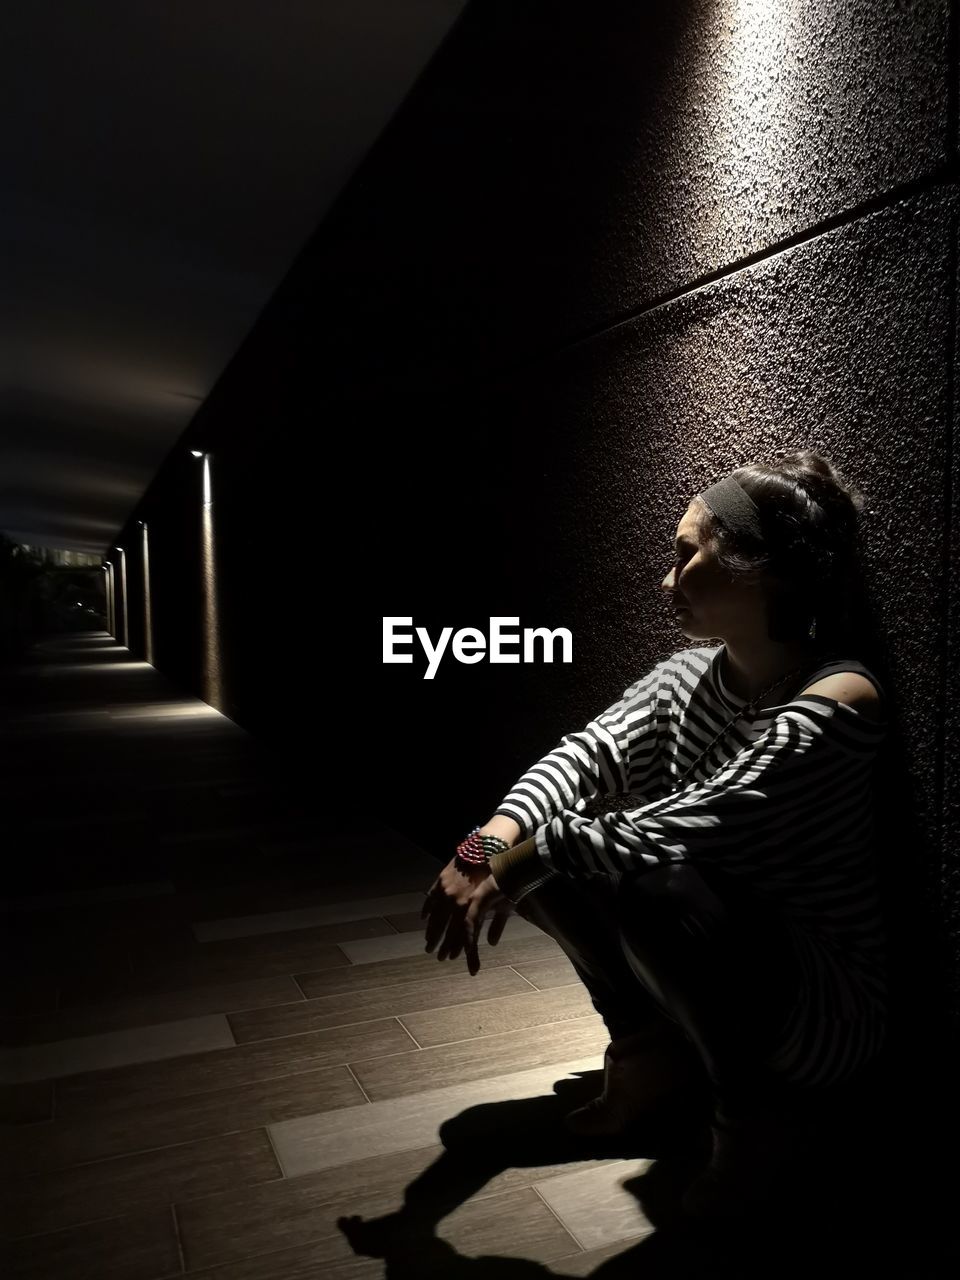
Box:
[534,695,886,878]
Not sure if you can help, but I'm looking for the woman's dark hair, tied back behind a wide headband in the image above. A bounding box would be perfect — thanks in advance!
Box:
[701,449,867,645]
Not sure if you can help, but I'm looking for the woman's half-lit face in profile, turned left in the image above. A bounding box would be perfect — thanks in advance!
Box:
[660,500,767,641]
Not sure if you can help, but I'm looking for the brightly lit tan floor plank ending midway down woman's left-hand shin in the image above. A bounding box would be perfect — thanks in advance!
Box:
[398,970,596,1048]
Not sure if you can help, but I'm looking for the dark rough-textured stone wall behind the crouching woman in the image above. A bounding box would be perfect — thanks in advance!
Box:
[114,0,960,1049]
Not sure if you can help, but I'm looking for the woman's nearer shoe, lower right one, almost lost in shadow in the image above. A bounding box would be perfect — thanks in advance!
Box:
[682,1106,818,1222]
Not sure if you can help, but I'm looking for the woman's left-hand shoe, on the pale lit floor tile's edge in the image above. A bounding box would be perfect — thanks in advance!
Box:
[563,1028,704,1137]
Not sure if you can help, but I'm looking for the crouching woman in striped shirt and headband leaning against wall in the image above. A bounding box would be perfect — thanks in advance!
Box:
[424,449,887,1216]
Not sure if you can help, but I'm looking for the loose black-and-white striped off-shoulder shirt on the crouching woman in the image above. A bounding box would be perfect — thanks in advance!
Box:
[497,645,887,1087]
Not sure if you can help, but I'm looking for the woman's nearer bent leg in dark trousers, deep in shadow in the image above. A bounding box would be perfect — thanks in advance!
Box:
[617,863,799,1114]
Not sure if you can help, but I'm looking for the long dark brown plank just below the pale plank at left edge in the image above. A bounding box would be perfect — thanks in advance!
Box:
[6,1066,370,1174]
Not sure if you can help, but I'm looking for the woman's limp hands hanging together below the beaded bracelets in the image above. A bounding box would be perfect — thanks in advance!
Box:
[420,861,513,974]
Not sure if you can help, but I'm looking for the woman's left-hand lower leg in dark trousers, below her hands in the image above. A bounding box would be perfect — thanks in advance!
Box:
[516,876,676,1039]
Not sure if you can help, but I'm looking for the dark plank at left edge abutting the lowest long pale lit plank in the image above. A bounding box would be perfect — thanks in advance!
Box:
[4,1129,282,1239]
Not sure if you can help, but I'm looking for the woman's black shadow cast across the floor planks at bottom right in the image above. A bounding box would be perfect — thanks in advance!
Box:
[337,1044,960,1280]
